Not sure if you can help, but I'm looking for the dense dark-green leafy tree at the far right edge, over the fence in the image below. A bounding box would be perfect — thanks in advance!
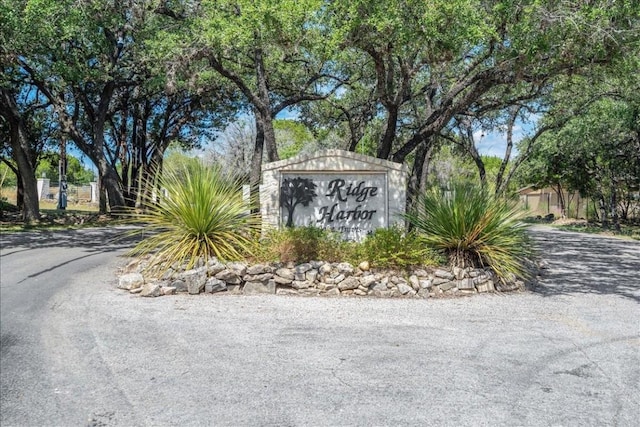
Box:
[521,63,640,228]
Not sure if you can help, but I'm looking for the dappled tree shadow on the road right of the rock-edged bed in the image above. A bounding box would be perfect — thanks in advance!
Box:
[529,227,640,302]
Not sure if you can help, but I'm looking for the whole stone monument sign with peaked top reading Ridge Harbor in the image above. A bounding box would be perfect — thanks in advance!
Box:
[260,150,407,240]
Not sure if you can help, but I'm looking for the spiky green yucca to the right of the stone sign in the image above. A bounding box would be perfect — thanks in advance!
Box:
[405,184,532,281]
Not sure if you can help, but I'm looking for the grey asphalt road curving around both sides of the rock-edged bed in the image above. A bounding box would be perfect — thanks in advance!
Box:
[0,229,640,427]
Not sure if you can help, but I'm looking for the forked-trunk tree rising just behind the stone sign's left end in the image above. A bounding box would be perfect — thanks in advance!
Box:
[155,0,336,191]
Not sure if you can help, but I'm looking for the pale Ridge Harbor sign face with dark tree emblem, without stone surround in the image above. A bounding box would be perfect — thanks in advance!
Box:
[280,172,389,240]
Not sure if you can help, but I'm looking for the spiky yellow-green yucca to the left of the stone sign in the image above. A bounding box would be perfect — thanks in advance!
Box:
[130,160,259,272]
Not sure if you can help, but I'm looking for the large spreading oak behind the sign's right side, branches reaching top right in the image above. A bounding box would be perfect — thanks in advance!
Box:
[320,0,639,196]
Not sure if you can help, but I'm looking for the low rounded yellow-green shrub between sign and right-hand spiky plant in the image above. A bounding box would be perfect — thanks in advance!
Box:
[356,227,441,268]
